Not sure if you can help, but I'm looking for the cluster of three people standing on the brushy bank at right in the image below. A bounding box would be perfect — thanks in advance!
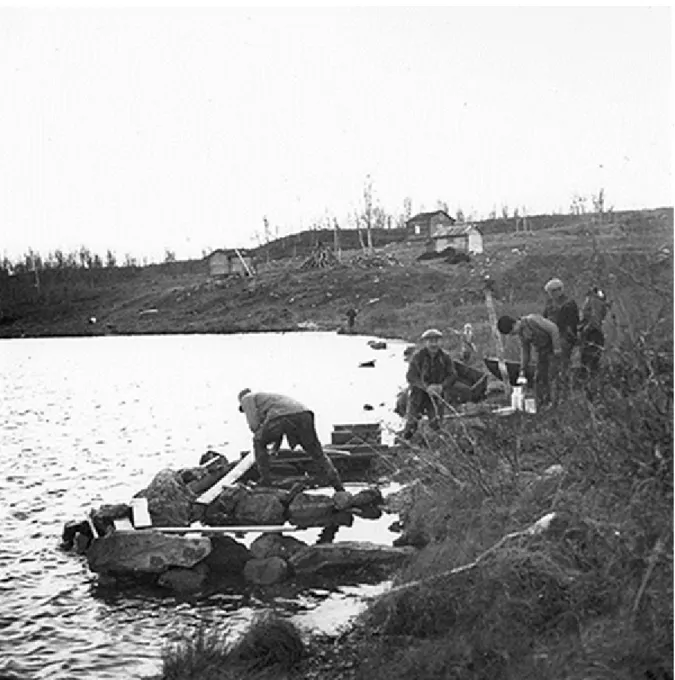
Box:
[497,279,609,407]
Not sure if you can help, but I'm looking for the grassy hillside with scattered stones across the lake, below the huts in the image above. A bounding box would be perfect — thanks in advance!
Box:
[0,209,673,356]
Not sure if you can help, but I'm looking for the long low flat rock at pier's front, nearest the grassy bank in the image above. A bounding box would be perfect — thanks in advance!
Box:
[289,541,416,574]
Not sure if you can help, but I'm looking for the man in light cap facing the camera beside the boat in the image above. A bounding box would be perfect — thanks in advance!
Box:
[402,328,457,439]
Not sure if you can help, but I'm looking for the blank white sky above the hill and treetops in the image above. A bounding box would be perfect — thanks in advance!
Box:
[0,7,673,260]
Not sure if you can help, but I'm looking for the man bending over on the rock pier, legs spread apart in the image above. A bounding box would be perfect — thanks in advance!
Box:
[238,389,344,491]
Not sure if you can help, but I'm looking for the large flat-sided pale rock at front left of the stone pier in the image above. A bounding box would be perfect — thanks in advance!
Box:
[87,530,211,574]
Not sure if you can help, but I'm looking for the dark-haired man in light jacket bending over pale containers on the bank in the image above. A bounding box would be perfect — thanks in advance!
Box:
[497,314,562,408]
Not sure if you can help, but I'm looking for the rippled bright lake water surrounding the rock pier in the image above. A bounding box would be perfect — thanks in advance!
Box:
[0,333,405,680]
